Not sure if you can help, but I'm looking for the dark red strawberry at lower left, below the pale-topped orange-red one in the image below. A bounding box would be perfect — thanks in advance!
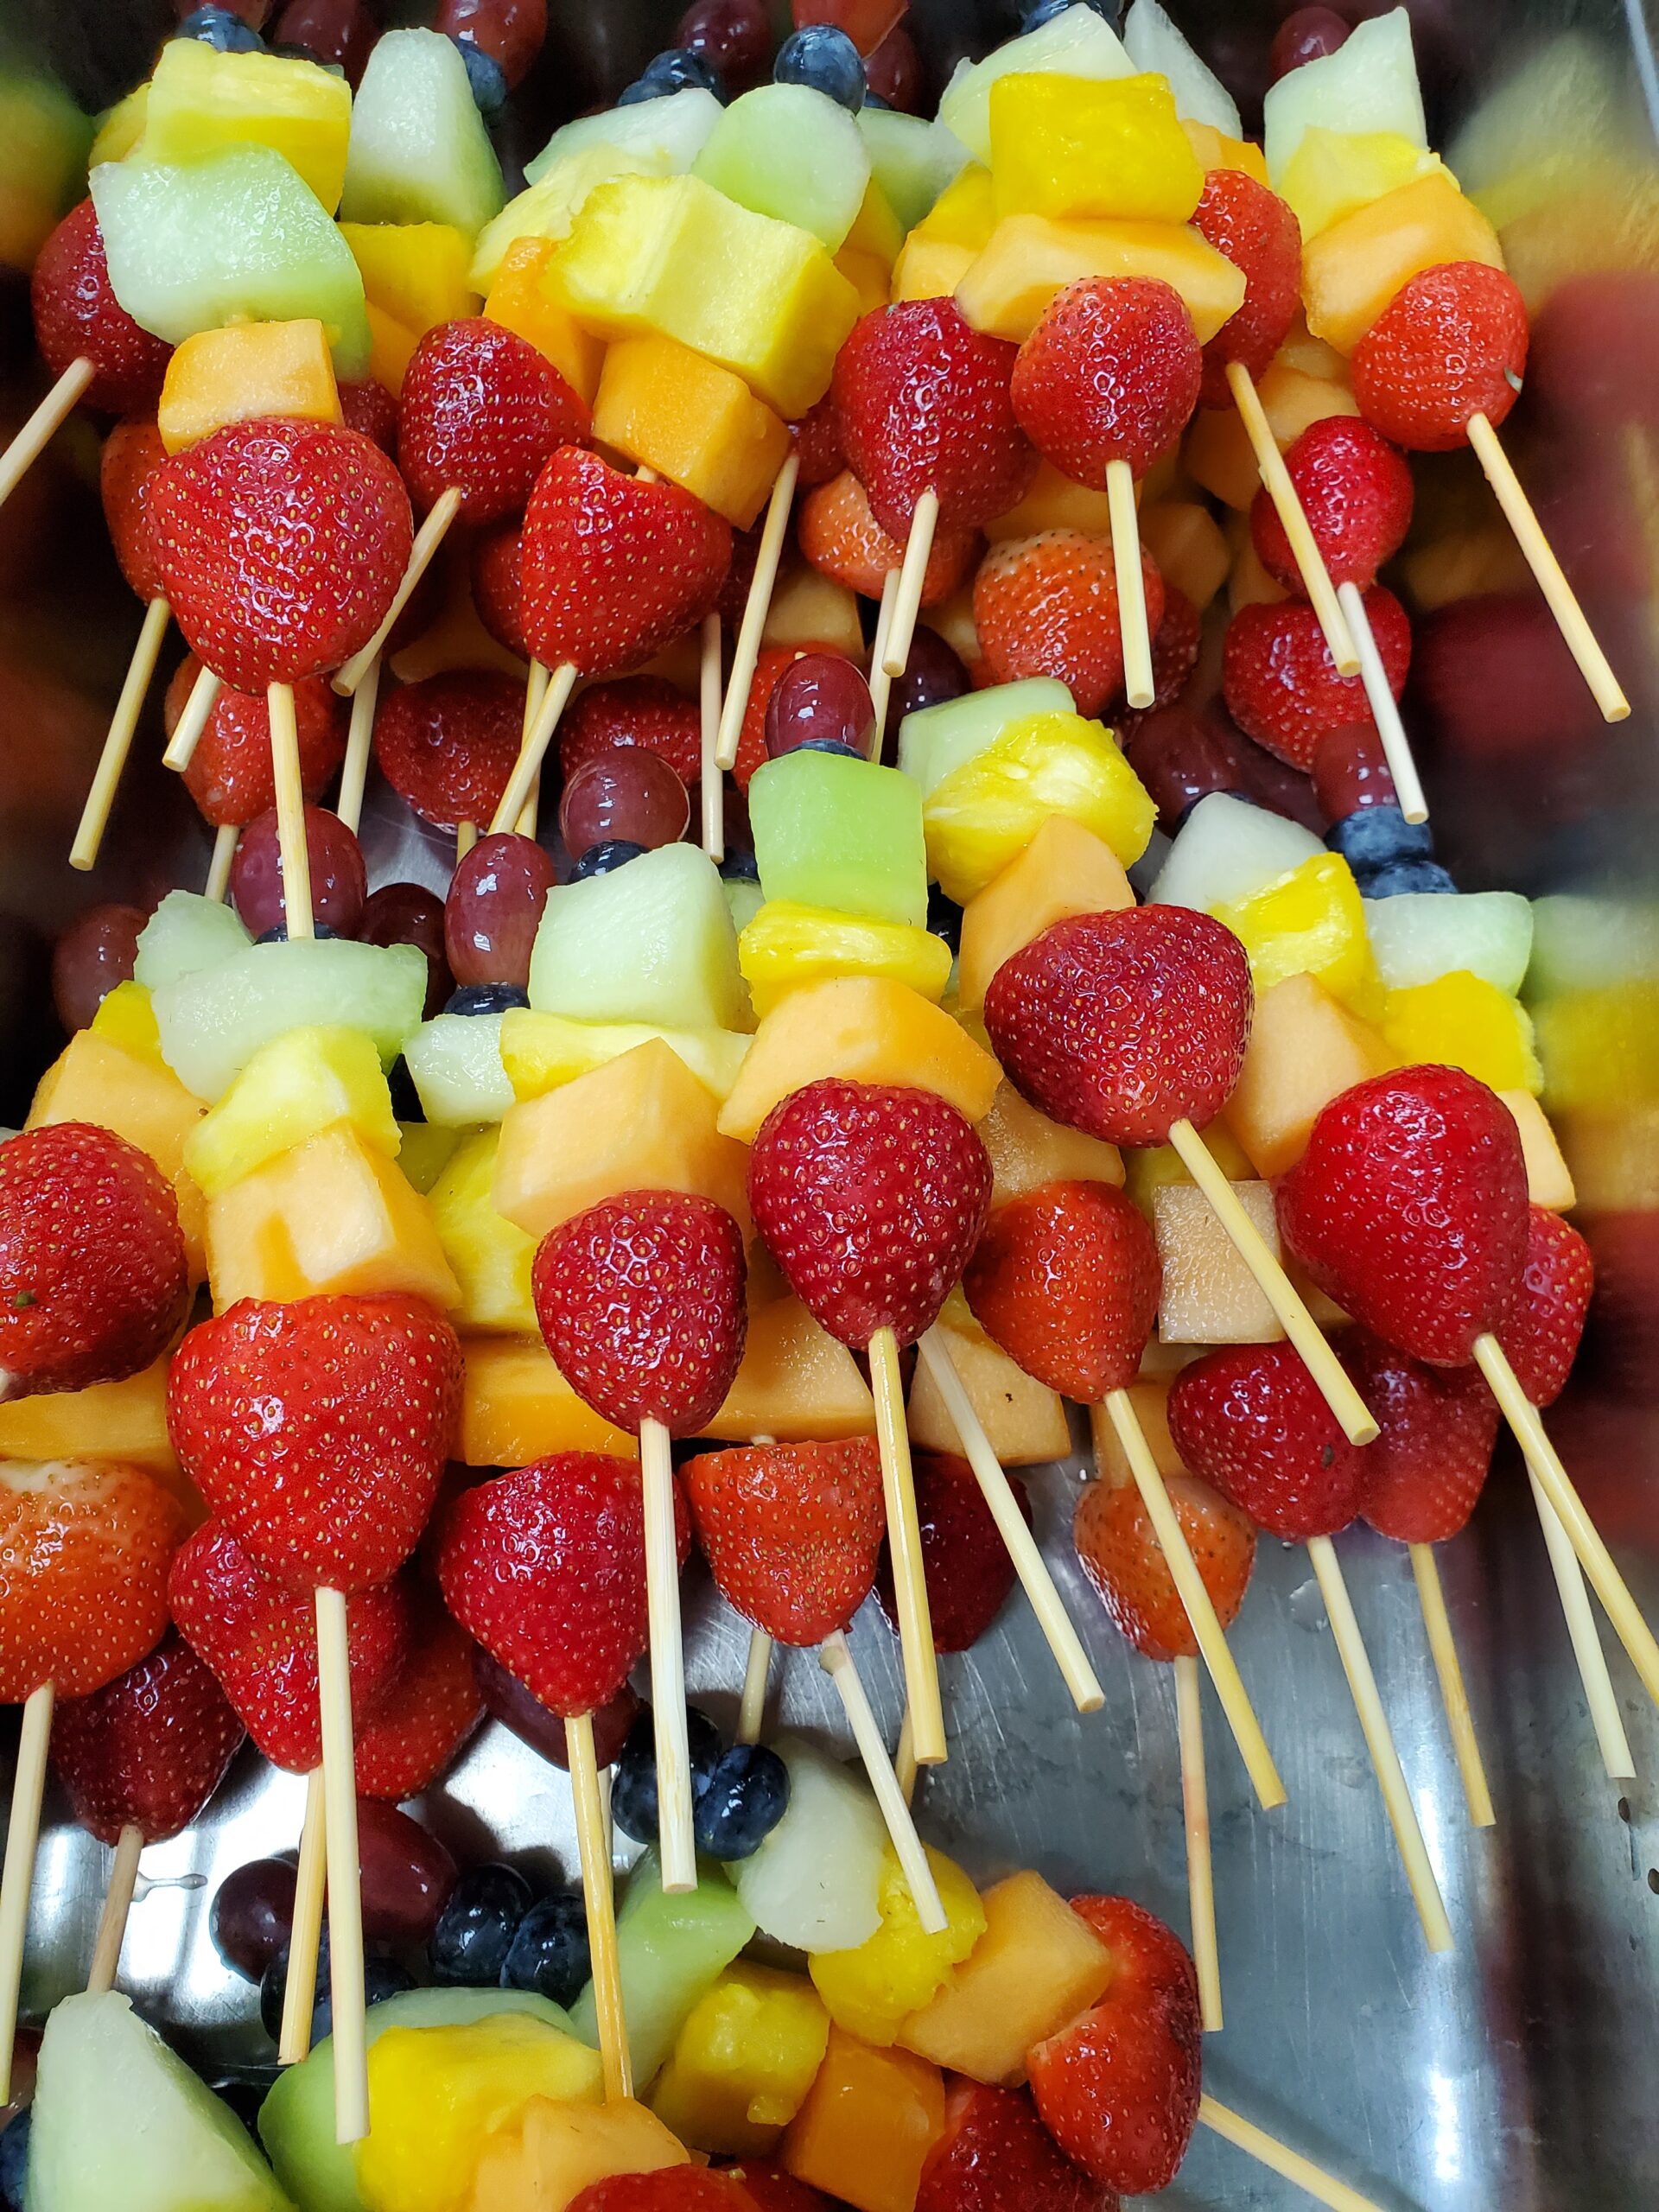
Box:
[51,1630,244,1842]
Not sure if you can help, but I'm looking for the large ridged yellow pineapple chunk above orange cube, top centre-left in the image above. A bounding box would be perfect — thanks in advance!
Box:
[550,177,858,423]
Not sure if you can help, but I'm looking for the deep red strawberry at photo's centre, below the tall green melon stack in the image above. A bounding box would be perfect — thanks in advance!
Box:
[750,1082,991,1351]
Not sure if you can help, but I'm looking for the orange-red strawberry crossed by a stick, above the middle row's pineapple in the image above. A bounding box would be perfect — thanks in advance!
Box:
[973,531,1164,715]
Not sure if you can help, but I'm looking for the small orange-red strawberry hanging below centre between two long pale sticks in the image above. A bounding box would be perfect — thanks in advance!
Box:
[679,1435,887,1646]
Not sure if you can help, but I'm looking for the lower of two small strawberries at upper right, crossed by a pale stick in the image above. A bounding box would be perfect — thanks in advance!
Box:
[1221,584,1411,772]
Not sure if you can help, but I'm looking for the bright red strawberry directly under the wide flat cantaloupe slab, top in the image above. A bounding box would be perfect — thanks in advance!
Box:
[1013,276,1204,491]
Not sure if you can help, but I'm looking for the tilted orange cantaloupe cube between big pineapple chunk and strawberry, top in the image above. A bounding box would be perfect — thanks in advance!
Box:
[593,332,796,531]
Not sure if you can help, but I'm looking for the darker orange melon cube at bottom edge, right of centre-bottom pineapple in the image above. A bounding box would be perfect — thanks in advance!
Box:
[779,2029,944,2212]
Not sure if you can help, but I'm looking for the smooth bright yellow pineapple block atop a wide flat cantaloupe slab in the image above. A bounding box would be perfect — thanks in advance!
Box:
[991,73,1204,224]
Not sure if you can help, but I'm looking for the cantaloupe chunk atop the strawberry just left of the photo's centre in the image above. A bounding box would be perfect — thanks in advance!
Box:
[495,1038,759,1239]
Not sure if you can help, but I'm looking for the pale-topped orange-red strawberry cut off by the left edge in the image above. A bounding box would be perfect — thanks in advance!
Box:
[0,1460,183,1706]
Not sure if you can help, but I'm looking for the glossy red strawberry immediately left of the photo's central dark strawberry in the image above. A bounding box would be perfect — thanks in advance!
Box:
[531,1190,747,1435]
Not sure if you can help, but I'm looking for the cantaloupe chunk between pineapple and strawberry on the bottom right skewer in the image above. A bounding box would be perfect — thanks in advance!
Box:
[898,1872,1113,2088]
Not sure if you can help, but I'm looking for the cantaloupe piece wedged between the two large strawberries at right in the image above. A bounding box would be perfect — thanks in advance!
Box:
[1224,976,1395,1179]
